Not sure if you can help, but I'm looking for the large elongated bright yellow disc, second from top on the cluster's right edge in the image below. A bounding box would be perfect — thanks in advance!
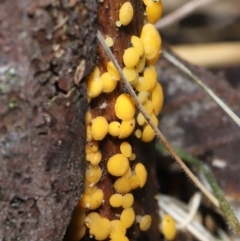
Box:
[140,23,161,64]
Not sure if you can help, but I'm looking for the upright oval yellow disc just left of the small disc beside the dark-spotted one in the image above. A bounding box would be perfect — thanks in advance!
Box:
[92,116,108,141]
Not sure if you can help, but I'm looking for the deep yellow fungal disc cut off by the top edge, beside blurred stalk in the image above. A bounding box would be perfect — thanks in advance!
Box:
[146,1,163,24]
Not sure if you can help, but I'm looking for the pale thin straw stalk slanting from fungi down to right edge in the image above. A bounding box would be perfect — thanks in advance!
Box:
[162,50,240,127]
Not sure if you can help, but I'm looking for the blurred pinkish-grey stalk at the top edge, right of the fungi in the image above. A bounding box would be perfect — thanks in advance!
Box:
[156,0,216,29]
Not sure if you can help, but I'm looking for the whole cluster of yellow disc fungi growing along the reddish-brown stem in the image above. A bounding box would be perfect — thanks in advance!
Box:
[67,0,172,241]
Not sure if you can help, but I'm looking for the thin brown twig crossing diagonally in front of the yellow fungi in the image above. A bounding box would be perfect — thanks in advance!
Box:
[97,31,219,207]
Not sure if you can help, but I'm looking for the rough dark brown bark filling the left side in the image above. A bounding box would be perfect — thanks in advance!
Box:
[0,0,97,240]
